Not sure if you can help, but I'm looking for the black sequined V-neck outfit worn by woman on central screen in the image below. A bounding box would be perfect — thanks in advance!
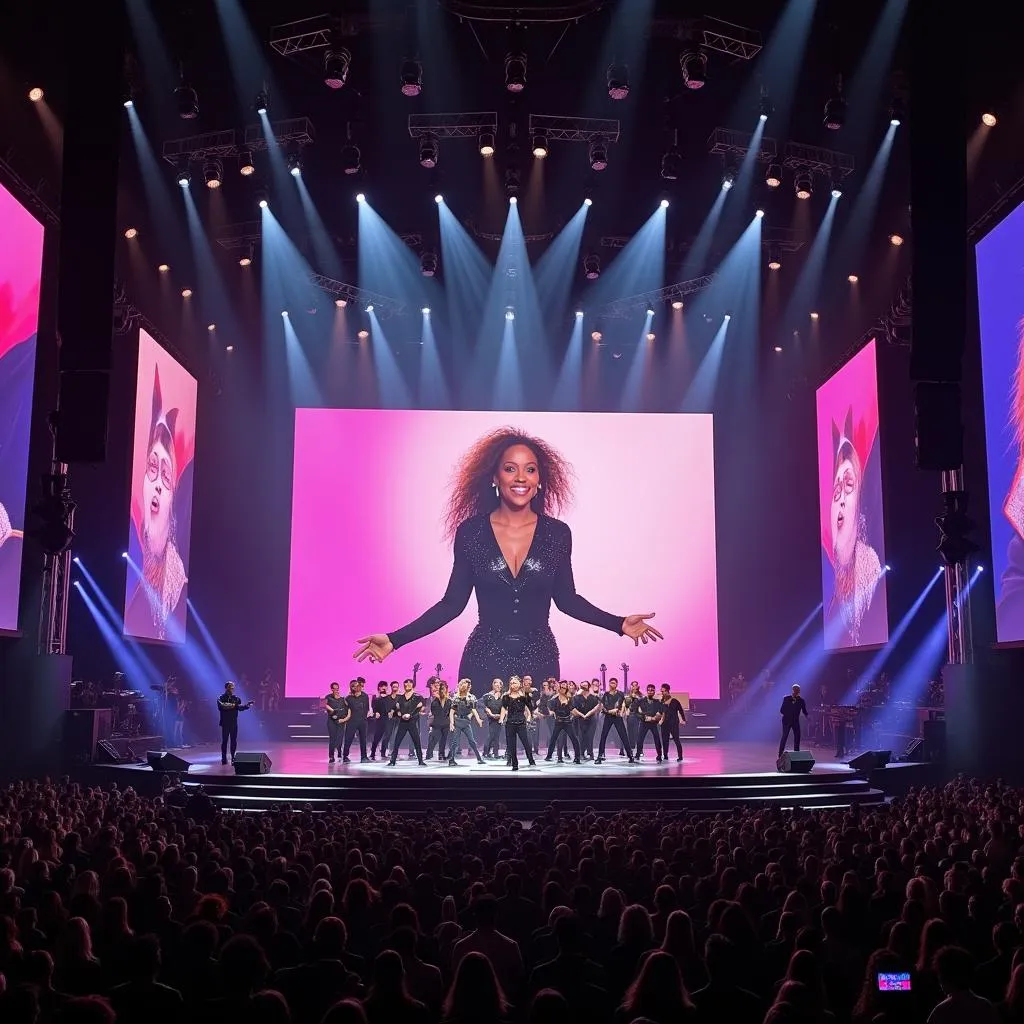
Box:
[388,515,623,689]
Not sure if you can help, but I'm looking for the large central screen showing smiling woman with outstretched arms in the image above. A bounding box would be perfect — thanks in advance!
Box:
[286,409,719,697]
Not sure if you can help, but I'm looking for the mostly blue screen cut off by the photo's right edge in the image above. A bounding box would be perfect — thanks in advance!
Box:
[975,204,1024,643]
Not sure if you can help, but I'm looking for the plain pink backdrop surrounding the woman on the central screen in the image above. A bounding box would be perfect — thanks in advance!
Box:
[286,409,719,697]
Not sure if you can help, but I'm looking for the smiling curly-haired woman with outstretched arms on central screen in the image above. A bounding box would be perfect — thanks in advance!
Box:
[354,427,662,685]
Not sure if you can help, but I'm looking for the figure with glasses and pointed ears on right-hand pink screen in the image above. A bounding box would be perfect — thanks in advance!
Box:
[825,415,882,647]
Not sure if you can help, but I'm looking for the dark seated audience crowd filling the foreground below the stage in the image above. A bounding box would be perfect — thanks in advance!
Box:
[0,779,1024,1024]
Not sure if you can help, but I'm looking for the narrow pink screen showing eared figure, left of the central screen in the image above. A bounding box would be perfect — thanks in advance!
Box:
[124,331,197,643]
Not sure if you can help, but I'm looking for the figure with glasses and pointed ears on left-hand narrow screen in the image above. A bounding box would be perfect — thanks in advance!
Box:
[125,369,188,640]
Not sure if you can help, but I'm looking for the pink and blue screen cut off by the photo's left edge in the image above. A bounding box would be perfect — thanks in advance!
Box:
[0,185,43,632]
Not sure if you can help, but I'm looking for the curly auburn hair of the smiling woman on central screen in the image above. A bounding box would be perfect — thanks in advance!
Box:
[444,427,573,540]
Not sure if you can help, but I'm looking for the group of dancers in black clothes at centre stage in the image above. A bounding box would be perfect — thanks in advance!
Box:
[323,676,686,771]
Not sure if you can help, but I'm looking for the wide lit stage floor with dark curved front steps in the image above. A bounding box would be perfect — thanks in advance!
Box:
[87,741,931,817]
